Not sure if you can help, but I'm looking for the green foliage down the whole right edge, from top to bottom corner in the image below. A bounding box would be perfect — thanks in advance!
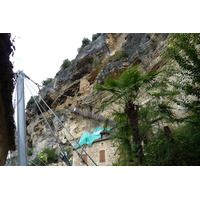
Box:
[152,33,200,165]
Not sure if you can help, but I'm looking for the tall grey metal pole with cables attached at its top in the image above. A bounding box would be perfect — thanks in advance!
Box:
[17,71,27,166]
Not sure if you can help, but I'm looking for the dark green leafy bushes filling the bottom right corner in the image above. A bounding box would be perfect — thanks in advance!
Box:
[144,124,200,166]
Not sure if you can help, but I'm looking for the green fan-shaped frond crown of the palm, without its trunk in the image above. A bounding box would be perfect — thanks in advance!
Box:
[95,66,160,108]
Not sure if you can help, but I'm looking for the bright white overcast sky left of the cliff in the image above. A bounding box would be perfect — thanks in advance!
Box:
[11,31,94,104]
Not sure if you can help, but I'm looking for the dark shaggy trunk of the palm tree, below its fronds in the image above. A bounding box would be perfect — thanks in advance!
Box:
[125,101,143,164]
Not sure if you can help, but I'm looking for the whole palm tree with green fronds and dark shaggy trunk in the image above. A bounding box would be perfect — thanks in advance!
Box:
[96,66,160,163]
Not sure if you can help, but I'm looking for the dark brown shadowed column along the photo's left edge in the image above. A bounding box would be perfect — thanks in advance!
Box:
[0,33,15,165]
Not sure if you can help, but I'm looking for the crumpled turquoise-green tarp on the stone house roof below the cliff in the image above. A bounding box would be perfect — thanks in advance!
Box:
[74,127,112,149]
